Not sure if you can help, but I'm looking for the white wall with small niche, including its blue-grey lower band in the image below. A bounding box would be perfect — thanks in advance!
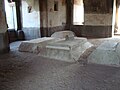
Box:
[22,0,41,40]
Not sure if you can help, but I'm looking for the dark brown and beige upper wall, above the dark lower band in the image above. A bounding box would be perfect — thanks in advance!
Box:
[84,0,113,26]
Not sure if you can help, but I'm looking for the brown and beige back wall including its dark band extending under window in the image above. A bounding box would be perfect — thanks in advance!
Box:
[71,0,113,38]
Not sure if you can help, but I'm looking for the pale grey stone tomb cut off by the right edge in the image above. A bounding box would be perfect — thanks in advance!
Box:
[88,41,120,66]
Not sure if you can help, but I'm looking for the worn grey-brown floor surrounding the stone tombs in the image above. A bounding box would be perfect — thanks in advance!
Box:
[0,38,120,90]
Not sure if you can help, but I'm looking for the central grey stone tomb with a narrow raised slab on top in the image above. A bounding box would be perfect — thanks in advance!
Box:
[39,37,92,62]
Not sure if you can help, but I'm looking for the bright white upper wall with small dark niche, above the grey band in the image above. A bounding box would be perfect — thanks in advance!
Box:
[22,0,40,27]
